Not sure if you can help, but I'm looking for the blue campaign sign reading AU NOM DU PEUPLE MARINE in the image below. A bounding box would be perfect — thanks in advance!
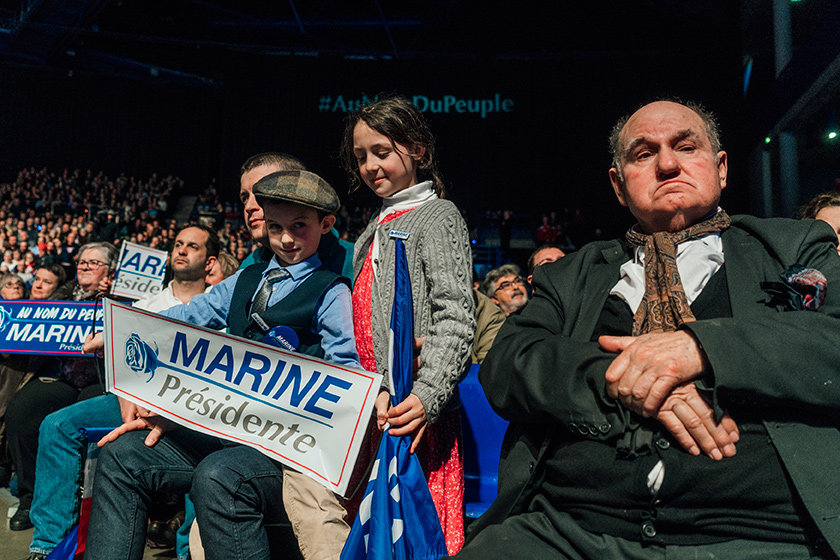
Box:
[0,300,103,356]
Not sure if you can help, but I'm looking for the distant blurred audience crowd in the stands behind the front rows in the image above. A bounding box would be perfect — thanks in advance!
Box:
[0,164,601,286]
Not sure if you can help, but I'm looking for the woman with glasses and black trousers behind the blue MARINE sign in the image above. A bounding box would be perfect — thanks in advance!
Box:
[6,242,119,531]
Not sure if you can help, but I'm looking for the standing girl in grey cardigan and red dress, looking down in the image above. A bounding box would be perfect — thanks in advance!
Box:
[342,97,475,554]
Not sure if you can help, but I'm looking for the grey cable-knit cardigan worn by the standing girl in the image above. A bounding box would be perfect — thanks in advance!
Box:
[353,199,475,422]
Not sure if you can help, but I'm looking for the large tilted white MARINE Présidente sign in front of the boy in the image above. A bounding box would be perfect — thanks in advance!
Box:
[104,300,382,495]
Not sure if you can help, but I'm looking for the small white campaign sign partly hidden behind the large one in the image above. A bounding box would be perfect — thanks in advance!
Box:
[111,241,167,299]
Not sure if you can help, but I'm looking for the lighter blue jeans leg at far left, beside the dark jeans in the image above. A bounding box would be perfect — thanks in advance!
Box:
[29,395,122,554]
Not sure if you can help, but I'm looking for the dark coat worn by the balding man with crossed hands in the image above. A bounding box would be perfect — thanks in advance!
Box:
[470,216,840,554]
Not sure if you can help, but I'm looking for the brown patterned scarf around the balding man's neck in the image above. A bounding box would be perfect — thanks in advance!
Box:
[627,210,732,336]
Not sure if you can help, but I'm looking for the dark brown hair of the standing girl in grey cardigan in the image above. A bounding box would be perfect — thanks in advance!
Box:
[341,96,446,198]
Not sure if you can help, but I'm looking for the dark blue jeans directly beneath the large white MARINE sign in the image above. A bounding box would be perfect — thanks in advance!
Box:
[85,429,286,560]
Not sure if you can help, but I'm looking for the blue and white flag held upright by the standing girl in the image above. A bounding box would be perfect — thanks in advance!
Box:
[341,235,447,560]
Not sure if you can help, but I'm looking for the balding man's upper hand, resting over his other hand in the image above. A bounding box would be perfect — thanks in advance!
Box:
[598,331,708,418]
